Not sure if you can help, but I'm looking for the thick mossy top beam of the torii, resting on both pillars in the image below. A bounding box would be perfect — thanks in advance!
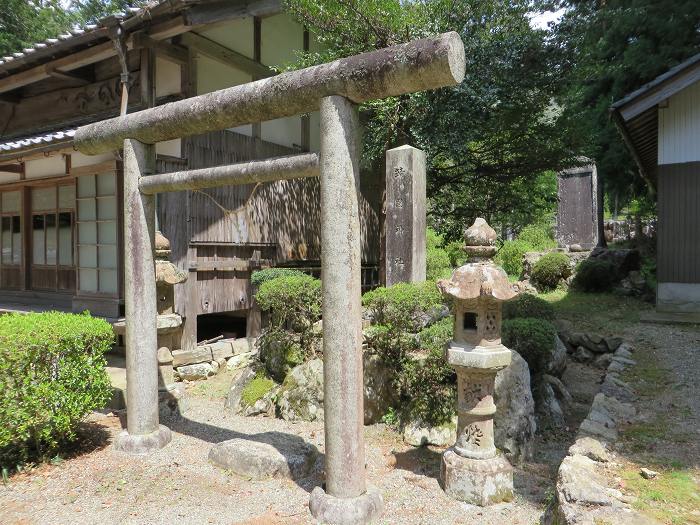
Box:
[74,32,465,155]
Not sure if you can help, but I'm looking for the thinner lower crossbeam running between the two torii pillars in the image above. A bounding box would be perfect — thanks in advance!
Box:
[139,153,319,195]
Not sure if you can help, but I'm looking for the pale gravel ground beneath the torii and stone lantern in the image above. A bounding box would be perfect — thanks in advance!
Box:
[0,392,551,525]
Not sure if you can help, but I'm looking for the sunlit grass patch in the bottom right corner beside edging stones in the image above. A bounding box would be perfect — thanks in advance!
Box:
[622,468,700,525]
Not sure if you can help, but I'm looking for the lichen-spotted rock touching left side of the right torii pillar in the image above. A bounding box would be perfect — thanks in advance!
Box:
[276,359,323,421]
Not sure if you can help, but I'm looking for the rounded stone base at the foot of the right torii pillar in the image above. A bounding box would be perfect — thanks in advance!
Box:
[309,487,384,525]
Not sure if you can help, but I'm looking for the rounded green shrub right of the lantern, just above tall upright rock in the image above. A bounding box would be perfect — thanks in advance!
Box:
[502,318,557,376]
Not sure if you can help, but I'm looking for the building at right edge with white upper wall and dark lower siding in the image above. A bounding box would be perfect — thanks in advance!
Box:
[611,54,700,313]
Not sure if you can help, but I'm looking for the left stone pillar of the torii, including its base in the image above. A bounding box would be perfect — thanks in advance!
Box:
[114,139,171,454]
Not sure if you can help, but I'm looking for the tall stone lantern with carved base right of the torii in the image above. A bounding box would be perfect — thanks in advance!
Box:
[438,218,515,506]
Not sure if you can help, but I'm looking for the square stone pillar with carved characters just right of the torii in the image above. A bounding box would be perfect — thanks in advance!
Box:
[384,146,426,286]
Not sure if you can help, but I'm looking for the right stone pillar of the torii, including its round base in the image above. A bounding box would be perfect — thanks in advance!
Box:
[309,96,383,525]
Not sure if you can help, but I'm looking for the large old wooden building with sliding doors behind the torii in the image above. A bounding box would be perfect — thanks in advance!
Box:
[0,0,381,346]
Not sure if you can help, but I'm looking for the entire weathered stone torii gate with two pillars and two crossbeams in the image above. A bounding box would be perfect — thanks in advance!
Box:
[75,32,465,524]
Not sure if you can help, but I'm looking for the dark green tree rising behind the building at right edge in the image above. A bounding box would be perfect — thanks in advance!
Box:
[554,0,700,207]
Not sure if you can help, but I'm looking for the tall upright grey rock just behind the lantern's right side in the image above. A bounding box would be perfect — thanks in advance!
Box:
[494,350,537,462]
